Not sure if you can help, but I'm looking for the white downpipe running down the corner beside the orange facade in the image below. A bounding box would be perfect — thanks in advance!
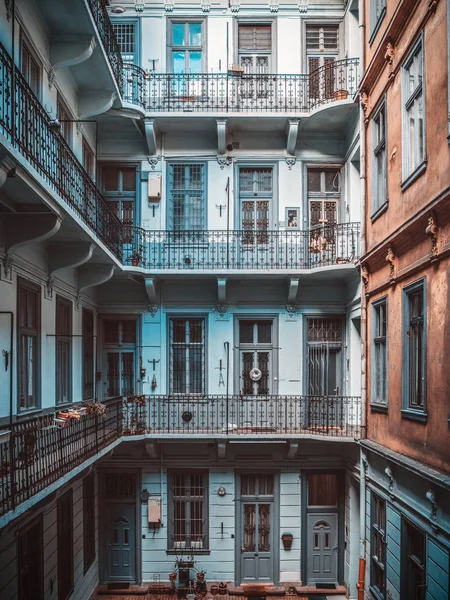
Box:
[356,0,367,600]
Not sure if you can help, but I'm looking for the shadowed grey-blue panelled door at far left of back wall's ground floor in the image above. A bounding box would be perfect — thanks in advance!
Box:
[107,504,136,581]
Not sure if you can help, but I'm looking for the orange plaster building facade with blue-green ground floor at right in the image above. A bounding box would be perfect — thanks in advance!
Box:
[361,1,450,599]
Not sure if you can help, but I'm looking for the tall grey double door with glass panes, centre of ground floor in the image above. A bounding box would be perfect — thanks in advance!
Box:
[239,475,275,583]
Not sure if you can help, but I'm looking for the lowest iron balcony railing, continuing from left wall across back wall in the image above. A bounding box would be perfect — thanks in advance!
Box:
[0,396,361,515]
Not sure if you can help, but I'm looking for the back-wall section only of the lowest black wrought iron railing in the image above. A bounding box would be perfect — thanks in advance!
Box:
[123,395,361,438]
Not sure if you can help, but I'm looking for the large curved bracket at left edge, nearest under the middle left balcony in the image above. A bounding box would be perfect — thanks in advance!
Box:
[2,213,62,253]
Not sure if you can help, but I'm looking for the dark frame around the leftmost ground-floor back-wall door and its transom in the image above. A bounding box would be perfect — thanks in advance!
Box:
[98,467,142,585]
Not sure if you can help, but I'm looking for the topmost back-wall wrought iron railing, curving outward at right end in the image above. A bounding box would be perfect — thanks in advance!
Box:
[146,58,359,113]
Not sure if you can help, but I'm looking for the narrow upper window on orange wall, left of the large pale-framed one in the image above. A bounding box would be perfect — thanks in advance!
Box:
[372,102,387,214]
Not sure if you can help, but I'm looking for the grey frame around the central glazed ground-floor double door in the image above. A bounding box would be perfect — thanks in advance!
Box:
[234,469,280,586]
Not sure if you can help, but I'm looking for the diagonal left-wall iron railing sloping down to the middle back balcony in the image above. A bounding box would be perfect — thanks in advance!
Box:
[0,45,123,258]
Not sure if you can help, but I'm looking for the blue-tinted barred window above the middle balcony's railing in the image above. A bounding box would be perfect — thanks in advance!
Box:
[168,163,206,231]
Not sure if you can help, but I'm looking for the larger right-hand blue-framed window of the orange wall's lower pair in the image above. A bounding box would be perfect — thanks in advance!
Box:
[402,280,426,416]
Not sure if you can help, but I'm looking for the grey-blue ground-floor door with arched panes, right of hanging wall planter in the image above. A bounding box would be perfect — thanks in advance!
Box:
[307,513,338,585]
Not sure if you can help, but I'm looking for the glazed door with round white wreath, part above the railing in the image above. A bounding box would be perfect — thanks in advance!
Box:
[239,319,273,396]
